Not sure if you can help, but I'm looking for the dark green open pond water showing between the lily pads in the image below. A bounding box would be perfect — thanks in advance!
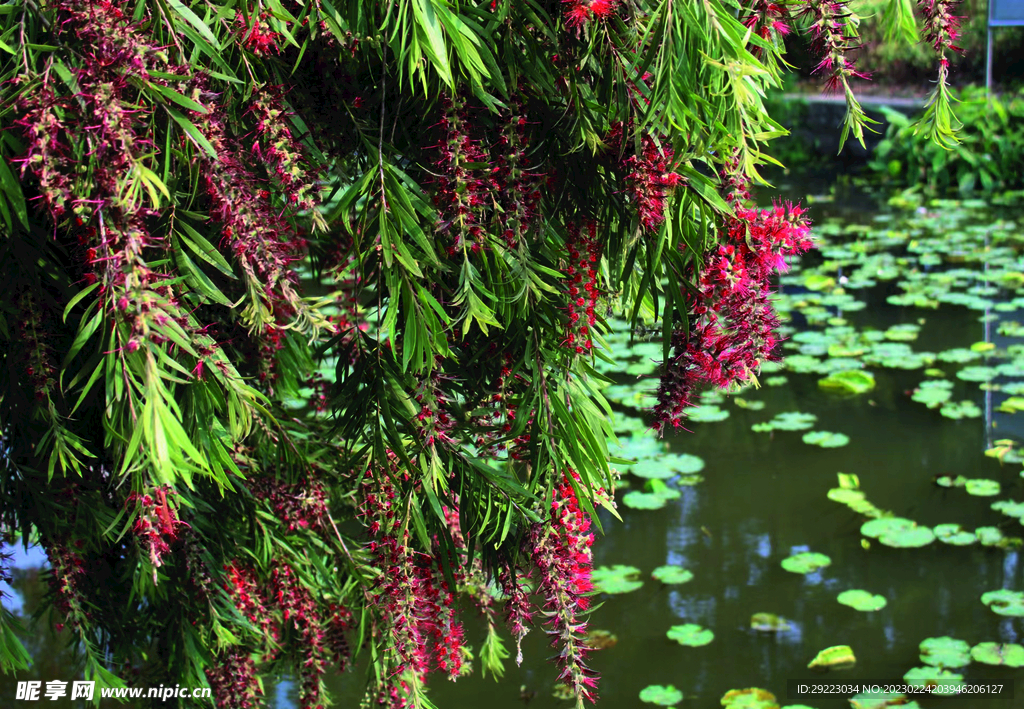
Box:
[0,180,1024,709]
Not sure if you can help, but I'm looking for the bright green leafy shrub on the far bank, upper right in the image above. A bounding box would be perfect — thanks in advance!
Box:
[868,87,1024,193]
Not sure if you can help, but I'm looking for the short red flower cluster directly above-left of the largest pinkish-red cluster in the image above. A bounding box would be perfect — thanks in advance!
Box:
[605,122,683,232]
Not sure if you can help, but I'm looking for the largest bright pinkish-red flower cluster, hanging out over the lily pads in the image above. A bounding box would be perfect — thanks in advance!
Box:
[653,170,811,433]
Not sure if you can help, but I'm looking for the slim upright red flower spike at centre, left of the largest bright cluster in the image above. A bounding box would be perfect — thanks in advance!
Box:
[563,221,601,355]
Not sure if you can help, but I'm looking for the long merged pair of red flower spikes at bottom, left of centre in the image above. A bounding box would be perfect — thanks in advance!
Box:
[360,469,463,709]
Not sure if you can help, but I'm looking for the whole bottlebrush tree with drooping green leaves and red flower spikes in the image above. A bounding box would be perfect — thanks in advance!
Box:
[0,0,956,708]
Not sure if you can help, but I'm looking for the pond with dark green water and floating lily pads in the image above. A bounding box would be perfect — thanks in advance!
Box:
[0,177,1024,709]
